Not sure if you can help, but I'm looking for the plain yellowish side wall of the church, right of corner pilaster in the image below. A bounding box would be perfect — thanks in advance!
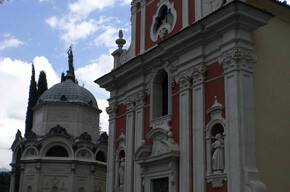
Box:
[249,0,290,192]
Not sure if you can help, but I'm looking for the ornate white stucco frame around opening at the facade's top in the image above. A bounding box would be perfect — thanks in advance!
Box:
[150,0,177,42]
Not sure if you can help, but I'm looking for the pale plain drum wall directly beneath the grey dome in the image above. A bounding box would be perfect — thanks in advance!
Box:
[32,103,99,139]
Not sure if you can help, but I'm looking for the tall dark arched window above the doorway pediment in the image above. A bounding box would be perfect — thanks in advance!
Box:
[152,69,168,119]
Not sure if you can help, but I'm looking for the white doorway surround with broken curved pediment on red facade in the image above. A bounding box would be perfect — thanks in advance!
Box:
[135,127,180,192]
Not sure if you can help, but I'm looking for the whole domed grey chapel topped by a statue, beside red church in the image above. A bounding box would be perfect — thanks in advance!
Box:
[10,49,108,192]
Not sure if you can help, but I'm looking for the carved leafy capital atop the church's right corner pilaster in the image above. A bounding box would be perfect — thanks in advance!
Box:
[218,47,257,73]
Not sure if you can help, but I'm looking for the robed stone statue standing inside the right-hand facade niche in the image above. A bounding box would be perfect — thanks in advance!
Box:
[212,133,225,174]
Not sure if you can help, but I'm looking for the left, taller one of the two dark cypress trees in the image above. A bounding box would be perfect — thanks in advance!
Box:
[25,64,37,134]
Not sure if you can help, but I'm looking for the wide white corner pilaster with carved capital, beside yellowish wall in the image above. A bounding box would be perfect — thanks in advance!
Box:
[219,47,267,192]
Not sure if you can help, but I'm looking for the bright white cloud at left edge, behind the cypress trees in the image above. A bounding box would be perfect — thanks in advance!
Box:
[0,56,60,169]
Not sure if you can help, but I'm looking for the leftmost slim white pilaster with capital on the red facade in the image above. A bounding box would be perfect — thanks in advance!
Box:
[106,104,117,192]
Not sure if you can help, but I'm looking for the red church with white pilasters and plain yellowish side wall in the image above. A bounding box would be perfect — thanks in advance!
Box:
[95,0,290,192]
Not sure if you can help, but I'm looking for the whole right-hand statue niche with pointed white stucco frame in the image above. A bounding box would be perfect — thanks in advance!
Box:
[205,96,227,188]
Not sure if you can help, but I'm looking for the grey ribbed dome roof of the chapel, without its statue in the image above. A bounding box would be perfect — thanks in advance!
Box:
[37,78,98,109]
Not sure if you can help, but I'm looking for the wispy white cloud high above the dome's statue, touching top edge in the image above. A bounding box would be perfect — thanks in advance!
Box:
[45,0,130,46]
